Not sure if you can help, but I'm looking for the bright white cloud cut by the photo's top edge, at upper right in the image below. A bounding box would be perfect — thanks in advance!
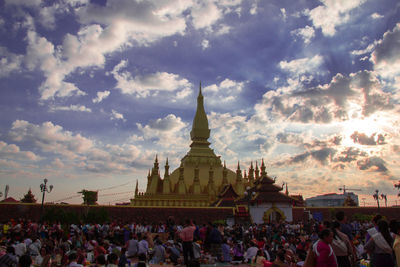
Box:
[305,0,365,36]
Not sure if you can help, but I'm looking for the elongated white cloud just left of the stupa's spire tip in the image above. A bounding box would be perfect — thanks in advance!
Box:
[112,60,191,97]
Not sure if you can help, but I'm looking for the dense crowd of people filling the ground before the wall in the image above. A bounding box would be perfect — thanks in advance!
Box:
[0,212,400,267]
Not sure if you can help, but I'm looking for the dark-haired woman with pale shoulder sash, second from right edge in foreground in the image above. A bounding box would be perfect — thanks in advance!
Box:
[365,220,394,267]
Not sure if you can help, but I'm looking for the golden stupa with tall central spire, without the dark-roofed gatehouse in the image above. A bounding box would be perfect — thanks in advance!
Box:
[131,84,259,207]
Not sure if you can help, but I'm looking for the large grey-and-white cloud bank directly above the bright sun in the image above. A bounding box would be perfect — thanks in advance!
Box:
[255,69,393,123]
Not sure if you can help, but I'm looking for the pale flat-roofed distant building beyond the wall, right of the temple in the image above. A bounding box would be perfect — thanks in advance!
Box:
[306,192,359,207]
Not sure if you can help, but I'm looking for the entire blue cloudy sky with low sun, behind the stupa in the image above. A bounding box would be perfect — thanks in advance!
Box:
[0,0,400,205]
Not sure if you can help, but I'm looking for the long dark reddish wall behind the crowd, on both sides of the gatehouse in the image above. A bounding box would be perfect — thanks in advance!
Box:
[0,203,400,224]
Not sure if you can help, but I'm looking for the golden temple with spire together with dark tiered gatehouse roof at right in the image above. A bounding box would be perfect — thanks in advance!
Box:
[131,84,293,219]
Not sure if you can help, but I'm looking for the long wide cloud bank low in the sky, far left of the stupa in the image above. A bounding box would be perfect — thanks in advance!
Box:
[5,120,148,174]
